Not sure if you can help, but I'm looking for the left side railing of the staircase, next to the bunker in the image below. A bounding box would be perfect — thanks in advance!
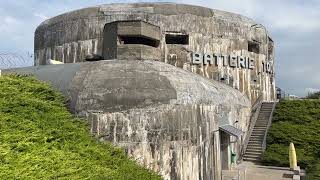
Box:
[239,95,263,159]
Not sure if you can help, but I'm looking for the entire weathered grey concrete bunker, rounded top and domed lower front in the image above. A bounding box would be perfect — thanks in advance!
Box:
[26,3,275,179]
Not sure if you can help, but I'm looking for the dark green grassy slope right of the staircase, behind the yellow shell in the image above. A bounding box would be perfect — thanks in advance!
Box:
[263,100,320,179]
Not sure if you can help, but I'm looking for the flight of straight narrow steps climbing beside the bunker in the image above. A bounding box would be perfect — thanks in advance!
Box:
[243,102,275,162]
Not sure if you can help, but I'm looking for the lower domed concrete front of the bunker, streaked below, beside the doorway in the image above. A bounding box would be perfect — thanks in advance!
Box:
[3,60,251,180]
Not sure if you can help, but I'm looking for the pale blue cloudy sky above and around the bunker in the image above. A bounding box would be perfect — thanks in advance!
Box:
[0,0,320,96]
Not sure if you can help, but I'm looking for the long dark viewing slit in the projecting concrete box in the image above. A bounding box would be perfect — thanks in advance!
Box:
[119,36,159,47]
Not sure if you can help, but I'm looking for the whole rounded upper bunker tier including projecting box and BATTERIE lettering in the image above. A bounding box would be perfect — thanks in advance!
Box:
[35,3,275,102]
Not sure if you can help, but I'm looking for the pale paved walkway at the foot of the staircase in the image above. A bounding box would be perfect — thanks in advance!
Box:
[222,161,293,180]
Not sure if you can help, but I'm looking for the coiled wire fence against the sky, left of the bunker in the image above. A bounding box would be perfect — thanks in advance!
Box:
[0,52,33,69]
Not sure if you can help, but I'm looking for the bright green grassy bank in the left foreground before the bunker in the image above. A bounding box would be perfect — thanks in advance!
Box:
[0,75,161,179]
